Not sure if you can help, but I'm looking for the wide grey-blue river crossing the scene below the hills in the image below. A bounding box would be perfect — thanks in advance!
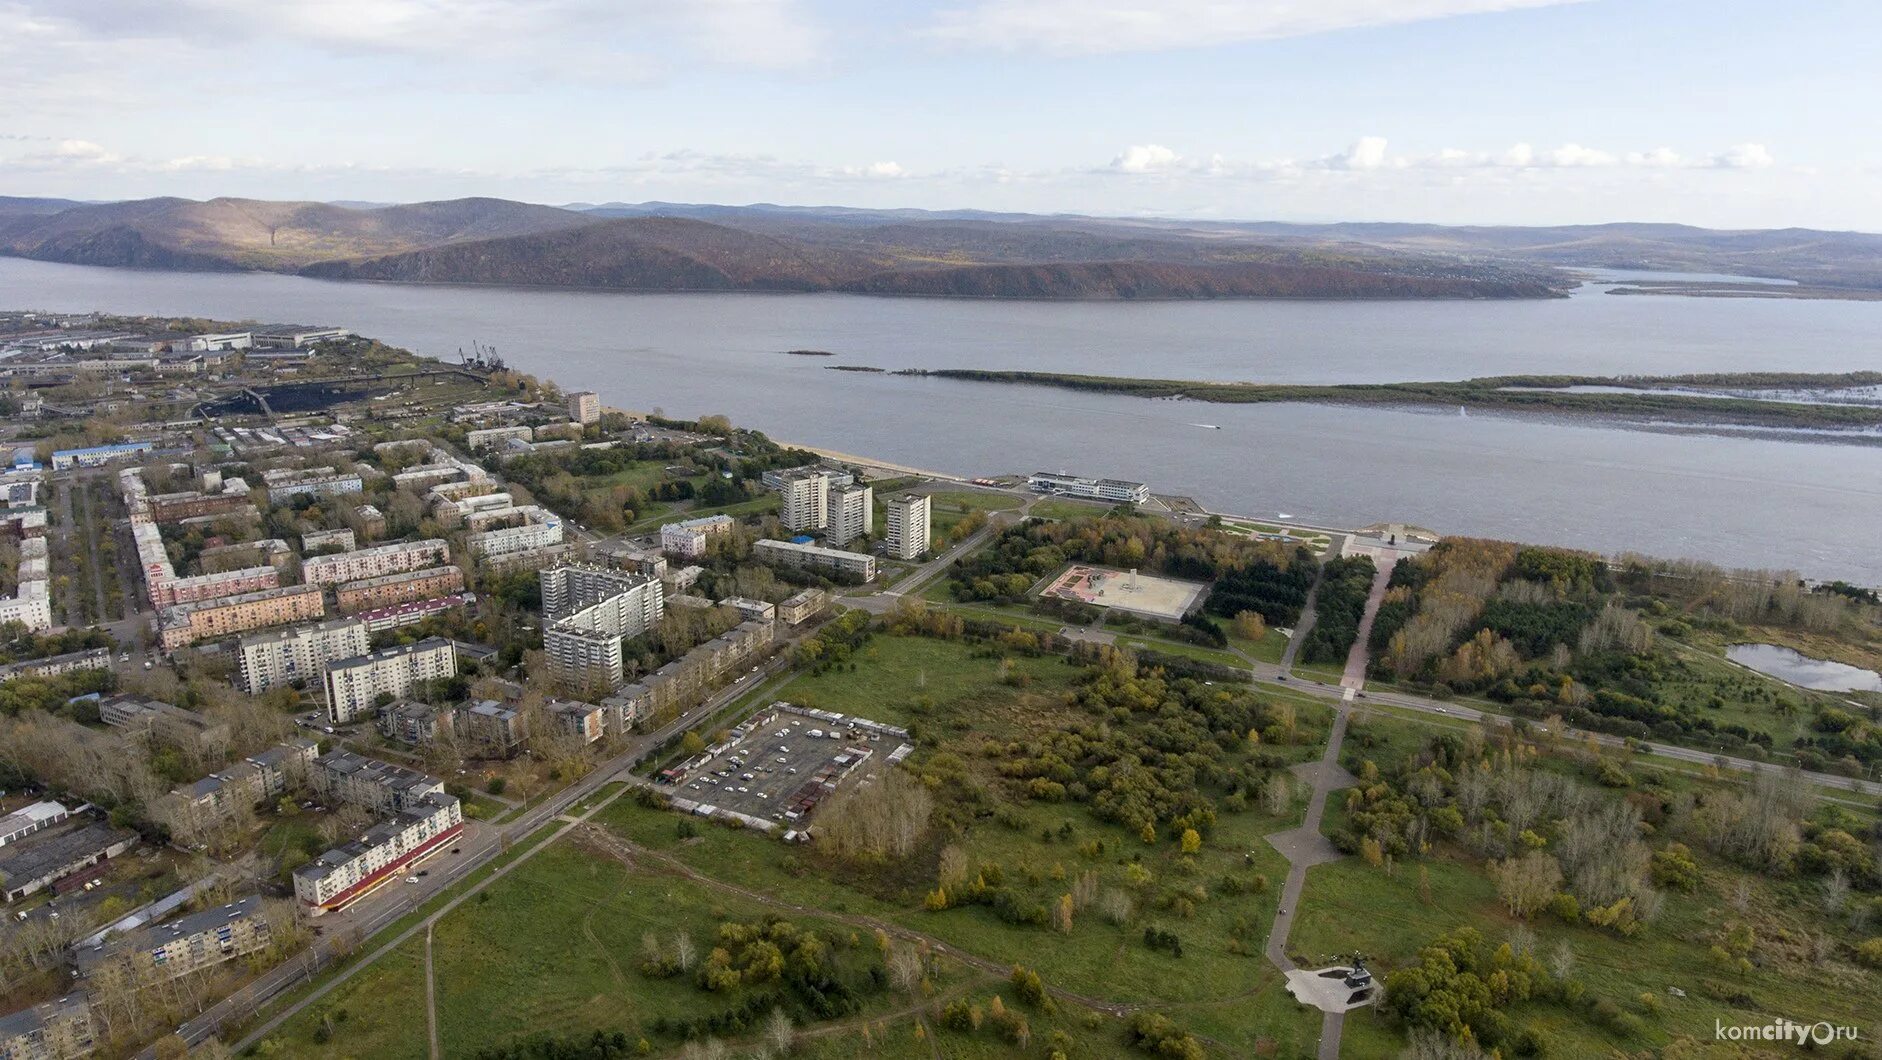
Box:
[0,258,1882,584]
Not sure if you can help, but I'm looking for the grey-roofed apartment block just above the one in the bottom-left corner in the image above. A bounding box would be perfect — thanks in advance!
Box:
[77,894,275,988]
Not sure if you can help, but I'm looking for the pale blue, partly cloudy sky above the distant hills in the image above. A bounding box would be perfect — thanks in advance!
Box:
[0,0,1882,232]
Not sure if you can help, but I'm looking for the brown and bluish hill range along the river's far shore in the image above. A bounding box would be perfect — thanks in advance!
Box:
[0,198,1882,299]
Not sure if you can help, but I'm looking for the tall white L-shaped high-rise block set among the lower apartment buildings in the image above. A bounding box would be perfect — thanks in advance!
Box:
[538,563,666,691]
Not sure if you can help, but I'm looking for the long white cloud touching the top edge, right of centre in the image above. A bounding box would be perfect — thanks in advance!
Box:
[928,0,1579,55]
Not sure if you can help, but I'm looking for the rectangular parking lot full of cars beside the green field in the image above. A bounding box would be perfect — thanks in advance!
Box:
[662,704,909,830]
